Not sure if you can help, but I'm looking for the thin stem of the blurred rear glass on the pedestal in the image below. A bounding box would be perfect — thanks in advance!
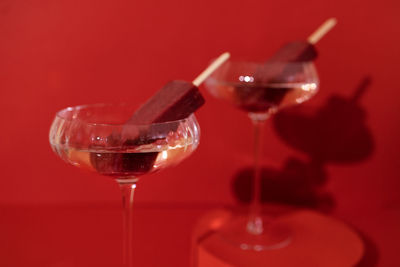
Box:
[247,114,268,235]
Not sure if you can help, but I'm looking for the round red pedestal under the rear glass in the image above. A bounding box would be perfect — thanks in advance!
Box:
[193,210,365,267]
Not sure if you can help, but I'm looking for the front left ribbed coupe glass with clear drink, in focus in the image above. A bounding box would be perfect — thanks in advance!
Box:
[50,104,200,267]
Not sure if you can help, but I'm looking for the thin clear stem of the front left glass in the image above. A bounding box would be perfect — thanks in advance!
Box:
[117,178,137,267]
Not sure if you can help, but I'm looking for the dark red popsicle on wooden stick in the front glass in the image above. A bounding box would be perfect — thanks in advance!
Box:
[90,53,230,175]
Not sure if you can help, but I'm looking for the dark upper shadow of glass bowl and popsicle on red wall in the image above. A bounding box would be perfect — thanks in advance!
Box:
[273,76,374,166]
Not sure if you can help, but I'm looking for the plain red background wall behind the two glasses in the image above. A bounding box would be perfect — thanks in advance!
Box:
[0,0,400,266]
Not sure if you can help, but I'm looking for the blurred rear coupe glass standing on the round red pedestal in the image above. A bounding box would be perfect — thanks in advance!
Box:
[206,61,319,250]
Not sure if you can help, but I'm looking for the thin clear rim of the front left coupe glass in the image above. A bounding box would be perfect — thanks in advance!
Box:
[56,103,194,127]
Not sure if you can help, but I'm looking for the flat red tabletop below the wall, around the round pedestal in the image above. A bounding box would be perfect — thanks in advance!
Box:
[0,204,400,267]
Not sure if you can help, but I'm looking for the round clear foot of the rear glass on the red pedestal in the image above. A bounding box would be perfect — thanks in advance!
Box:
[218,215,292,251]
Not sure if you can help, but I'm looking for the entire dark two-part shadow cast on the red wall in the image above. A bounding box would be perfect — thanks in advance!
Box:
[232,76,374,212]
